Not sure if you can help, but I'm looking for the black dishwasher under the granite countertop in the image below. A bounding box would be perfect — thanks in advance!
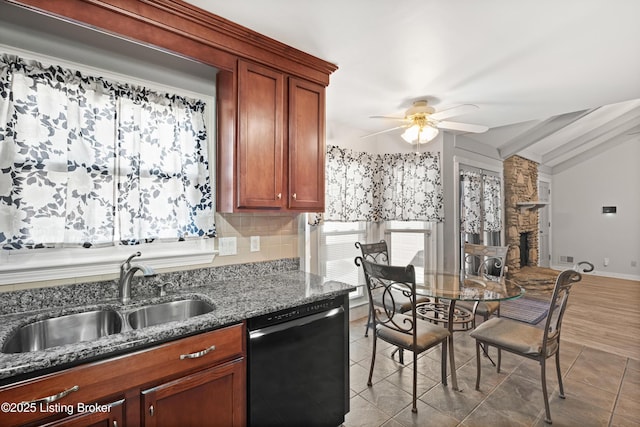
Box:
[247,296,349,427]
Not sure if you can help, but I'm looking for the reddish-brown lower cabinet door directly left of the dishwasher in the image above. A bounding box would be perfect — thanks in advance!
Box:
[141,359,246,427]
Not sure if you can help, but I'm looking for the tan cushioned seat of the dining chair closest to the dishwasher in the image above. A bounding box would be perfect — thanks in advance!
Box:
[376,314,451,353]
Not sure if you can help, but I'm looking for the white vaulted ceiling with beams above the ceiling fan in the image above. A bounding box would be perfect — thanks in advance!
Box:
[189,0,640,174]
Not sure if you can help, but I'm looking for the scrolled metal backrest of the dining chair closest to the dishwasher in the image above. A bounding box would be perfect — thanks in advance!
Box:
[355,257,416,336]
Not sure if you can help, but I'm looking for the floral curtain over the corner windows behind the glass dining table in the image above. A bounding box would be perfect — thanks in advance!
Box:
[324,146,443,222]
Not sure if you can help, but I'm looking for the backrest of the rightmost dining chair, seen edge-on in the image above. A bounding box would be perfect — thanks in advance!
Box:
[541,261,593,355]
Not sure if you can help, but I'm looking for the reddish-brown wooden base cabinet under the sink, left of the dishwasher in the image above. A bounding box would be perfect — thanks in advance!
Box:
[0,324,246,427]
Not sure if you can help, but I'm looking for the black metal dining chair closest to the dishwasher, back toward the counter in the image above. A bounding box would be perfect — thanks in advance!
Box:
[355,257,450,412]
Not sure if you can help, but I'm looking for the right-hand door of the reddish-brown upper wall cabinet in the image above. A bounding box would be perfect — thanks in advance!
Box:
[288,78,325,212]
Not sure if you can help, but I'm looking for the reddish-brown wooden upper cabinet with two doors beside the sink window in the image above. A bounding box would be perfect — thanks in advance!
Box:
[217,60,325,212]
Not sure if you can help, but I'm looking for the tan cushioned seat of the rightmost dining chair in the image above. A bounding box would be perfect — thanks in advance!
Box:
[469,317,544,356]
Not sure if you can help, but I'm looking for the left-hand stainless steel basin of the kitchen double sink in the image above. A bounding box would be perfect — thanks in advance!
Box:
[2,309,122,353]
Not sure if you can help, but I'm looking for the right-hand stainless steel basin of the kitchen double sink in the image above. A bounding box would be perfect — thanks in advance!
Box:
[128,299,213,329]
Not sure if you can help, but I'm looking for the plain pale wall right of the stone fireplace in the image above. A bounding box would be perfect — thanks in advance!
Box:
[551,135,640,280]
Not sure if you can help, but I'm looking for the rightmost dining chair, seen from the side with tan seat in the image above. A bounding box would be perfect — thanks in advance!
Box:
[470,261,593,424]
